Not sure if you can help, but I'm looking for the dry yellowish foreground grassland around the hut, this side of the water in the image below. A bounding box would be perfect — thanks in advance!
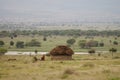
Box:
[0,53,120,80]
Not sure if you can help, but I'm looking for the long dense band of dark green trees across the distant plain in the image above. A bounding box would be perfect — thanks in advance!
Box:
[0,29,120,37]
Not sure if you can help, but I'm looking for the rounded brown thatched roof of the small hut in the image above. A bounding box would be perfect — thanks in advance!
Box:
[50,46,74,56]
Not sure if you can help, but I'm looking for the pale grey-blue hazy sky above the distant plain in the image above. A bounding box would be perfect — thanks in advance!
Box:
[0,0,120,19]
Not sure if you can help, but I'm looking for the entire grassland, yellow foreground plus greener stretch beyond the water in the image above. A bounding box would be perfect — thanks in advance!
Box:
[0,29,120,80]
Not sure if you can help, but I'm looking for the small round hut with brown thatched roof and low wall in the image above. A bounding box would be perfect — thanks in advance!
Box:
[50,45,74,60]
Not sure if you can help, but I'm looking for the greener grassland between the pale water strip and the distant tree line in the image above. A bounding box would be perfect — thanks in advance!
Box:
[0,35,120,52]
